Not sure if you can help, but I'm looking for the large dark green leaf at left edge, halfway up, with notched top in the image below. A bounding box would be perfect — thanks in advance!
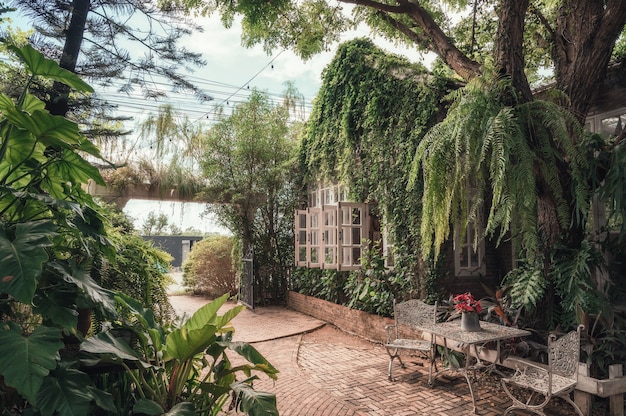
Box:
[0,221,56,304]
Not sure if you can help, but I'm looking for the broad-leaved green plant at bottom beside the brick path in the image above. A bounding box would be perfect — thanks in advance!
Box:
[81,293,278,416]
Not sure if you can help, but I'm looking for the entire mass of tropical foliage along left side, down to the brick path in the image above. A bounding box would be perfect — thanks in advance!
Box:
[0,40,277,416]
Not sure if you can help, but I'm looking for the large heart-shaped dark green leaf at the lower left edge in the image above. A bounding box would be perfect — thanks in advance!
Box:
[0,322,63,403]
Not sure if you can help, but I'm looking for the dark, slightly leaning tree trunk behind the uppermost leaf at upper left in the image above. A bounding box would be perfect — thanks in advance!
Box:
[47,0,90,116]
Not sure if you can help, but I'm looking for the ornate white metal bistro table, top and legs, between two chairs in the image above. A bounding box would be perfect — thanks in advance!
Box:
[419,320,531,413]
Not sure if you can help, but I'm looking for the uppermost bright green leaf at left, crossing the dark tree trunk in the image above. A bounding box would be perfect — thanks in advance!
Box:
[8,44,93,92]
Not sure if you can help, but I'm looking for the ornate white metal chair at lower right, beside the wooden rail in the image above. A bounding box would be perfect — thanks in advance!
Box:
[502,325,584,416]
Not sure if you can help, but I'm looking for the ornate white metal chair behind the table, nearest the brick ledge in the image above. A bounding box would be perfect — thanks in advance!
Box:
[385,299,437,380]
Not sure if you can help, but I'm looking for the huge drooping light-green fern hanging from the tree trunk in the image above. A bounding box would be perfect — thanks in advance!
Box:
[410,71,589,261]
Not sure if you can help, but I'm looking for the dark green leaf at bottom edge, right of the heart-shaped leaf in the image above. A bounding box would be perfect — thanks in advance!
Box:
[35,365,94,416]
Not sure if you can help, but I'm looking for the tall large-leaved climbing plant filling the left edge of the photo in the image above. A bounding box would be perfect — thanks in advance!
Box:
[0,46,115,414]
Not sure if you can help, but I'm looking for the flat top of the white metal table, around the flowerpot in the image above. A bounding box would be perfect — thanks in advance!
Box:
[419,320,531,345]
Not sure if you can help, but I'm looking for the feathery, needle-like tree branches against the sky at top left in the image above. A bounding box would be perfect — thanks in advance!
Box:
[9,0,210,115]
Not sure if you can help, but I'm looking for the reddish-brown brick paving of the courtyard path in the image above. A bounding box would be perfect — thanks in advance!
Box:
[173,297,596,416]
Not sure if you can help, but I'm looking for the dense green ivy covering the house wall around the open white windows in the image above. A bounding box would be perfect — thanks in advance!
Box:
[295,39,458,312]
